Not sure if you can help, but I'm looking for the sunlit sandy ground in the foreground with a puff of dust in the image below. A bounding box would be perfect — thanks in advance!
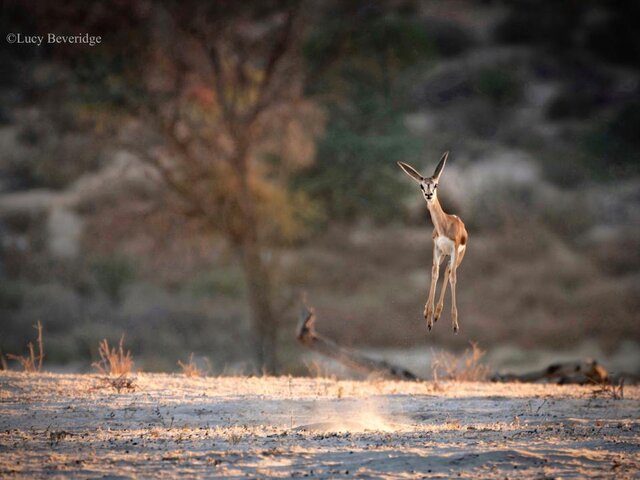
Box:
[0,372,640,478]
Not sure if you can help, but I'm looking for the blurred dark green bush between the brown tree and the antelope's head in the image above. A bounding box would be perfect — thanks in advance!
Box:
[293,6,430,222]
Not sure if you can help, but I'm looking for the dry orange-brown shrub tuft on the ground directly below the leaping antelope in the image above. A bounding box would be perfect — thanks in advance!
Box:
[431,342,489,383]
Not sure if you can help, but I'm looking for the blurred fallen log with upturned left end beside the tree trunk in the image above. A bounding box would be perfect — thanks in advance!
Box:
[296,305,422,381]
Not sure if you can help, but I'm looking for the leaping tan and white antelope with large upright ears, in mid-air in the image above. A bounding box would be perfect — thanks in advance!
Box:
[398,152,468,333]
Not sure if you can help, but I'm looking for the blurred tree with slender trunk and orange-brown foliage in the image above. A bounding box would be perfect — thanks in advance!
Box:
[129,2,322,372]
